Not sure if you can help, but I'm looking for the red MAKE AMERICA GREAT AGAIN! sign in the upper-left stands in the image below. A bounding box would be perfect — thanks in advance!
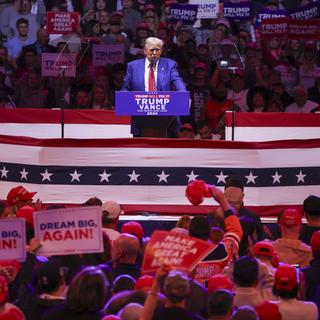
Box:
[47,12,80,34]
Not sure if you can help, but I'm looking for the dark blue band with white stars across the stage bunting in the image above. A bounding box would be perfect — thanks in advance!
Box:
[0,162,320,187]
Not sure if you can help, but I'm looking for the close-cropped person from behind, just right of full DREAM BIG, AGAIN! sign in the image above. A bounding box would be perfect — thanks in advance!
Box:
[112,233,141,279]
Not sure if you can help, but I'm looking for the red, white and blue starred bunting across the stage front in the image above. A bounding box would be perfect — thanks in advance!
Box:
[0,136,320,215]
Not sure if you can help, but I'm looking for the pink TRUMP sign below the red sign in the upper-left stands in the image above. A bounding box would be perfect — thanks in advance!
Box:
[41,53,76,78]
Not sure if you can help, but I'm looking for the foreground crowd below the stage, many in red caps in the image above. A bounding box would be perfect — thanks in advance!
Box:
[0,178,320,320]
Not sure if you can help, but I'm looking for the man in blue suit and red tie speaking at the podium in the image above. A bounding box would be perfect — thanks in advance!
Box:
[121,37,187,136]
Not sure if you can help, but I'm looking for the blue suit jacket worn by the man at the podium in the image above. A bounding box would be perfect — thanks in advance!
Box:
[121,58,187,91]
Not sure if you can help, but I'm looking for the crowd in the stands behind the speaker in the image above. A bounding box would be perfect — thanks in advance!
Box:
[0,0,320,139]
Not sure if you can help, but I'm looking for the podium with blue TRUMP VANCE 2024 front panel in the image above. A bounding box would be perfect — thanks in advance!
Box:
[115,91,190,138]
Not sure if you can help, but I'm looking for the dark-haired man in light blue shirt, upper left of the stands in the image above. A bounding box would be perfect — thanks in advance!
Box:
[7,18,34,59]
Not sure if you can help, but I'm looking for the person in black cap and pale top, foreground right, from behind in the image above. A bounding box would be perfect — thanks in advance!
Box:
[233,256,264,307]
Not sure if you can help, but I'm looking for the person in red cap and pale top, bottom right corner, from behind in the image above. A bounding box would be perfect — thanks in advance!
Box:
[273,264,318,320]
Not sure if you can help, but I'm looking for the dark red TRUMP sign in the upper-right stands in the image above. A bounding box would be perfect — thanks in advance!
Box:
[260,18,288,39]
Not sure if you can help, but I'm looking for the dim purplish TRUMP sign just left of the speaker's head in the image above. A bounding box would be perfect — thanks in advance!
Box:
[92,44,124,66]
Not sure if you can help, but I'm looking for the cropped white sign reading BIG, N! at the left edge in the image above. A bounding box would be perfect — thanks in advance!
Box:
[0,218,26,261]
